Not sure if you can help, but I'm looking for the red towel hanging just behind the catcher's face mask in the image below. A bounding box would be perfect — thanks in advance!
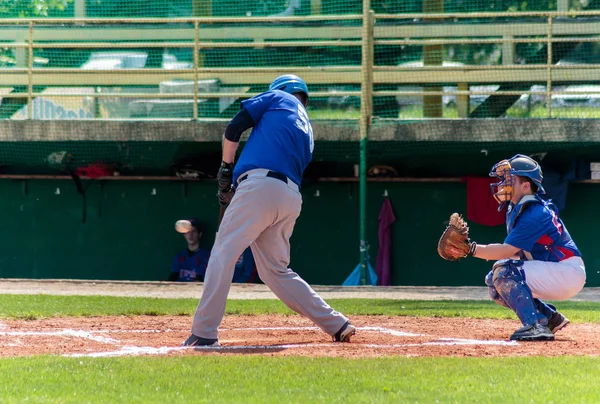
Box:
[466,177,506,226]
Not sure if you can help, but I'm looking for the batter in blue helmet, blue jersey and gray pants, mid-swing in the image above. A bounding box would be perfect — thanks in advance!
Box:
[183,74,355,346]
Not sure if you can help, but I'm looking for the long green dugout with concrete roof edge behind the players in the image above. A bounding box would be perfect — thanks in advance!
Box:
[0,119,600,286]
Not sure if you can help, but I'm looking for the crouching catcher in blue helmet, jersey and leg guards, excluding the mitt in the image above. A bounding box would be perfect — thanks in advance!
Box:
[440,154,586,341]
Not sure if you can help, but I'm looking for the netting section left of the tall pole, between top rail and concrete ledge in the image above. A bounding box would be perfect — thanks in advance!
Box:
[0,19,361,119]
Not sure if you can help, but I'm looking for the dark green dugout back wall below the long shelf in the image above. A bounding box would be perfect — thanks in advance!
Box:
[0,180,600,286]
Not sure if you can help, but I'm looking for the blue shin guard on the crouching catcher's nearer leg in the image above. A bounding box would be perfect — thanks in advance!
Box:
[492,260,538,325]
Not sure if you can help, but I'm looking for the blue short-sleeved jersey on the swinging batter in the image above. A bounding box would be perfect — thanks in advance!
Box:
[233,90,314,186]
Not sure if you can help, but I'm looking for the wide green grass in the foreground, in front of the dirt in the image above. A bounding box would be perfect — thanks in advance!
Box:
[0,356,600,403]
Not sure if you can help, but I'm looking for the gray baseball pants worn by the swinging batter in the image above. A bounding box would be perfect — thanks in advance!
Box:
[192,169,348,339]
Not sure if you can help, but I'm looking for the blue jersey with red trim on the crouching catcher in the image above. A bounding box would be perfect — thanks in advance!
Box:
[504,195,581,262]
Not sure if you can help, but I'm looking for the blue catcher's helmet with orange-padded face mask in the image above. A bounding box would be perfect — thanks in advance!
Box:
[490,154,545,211]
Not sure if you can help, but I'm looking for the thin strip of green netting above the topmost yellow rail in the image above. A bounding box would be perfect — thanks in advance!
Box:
[0,0,596,18]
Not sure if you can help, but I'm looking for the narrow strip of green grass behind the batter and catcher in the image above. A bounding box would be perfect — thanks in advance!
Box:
[0,295,600,322]
